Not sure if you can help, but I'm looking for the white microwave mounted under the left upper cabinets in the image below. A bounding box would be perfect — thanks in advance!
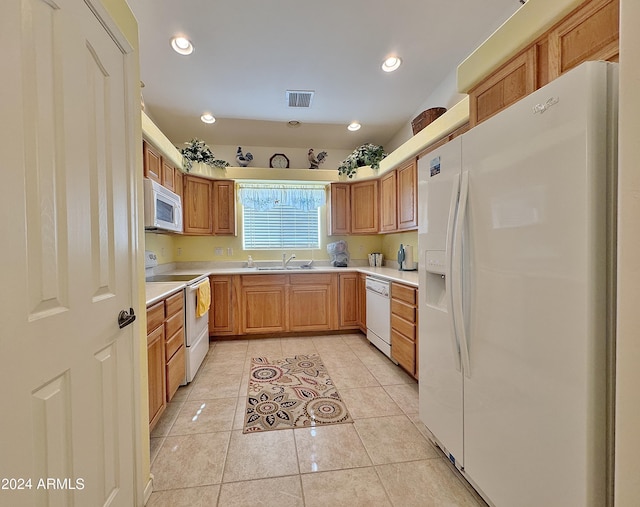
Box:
[144,178,182,232]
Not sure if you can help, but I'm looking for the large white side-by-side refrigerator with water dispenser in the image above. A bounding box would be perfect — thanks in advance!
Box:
[418,62,617,507]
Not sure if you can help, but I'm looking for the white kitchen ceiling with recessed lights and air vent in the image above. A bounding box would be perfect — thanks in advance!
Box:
[128,0,520,150]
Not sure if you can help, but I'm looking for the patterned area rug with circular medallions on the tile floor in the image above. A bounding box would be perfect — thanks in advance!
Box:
[243,354,353,433]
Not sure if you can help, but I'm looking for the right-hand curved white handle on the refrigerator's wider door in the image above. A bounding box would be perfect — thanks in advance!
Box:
[450,171,471,378]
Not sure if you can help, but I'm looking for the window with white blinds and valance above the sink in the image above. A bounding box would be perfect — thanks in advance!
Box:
[240,183,325,250]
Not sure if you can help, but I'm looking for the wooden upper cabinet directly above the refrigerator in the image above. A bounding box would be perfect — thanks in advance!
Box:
[469,0,620,127]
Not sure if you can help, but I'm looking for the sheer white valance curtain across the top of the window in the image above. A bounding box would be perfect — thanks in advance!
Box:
[238,183,326,211]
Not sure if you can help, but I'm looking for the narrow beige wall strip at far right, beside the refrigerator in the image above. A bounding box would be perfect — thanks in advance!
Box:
[615,0,640,507]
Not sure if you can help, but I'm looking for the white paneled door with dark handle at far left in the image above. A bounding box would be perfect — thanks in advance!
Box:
[0,0,139,506]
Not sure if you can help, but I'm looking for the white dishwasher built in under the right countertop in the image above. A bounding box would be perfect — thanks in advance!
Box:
[366,276,391,358]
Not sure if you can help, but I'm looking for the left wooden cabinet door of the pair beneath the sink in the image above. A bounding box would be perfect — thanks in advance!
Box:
[241,284,287,333]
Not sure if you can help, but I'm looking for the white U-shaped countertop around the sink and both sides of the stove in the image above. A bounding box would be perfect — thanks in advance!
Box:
[146,266,418,306]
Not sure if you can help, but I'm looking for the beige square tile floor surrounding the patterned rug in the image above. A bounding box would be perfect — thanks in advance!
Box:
[148,334,486,507]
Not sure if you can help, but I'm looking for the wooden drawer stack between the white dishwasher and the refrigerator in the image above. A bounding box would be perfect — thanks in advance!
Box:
[391,282,418,378]
